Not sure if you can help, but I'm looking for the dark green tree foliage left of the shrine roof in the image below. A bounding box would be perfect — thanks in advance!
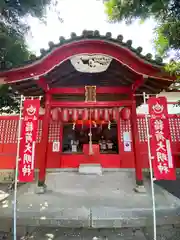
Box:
[0,0,57,113]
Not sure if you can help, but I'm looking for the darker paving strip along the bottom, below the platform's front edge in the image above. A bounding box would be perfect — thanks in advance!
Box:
[0,226,180,240]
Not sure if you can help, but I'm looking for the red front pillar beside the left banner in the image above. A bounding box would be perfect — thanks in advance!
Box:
[38,93,51,186]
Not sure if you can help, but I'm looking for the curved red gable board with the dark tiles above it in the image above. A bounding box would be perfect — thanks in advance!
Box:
[0,31,173,82]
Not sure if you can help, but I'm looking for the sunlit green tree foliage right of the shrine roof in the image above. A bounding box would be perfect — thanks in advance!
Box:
[104,0,180,86]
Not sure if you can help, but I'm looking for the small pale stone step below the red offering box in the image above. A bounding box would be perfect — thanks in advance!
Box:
[79,163,102,175]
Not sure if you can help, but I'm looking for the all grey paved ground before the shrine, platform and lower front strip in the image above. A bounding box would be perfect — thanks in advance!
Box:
[0,172,180,240]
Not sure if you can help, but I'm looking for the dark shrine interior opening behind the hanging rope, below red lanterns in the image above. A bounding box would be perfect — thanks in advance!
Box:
[62,122,119,154]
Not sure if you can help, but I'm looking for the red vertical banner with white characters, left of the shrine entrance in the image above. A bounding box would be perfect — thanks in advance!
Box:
[18,99,40,182]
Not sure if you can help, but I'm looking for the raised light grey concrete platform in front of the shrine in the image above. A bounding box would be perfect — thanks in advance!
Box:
[0,172,180,228]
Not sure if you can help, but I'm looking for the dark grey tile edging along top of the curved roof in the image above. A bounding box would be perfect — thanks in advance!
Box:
[0,30,165,71]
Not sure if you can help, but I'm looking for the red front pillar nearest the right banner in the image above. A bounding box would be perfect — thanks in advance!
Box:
[131,99,143,185]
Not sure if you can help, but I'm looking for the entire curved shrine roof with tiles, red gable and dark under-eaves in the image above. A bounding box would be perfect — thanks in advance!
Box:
[0,30,175,103]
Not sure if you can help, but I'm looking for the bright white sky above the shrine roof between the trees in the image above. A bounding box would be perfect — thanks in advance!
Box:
[27,0,155,55]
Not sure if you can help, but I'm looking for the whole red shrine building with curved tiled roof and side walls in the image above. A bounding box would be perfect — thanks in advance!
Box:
[0,31,180,185]
